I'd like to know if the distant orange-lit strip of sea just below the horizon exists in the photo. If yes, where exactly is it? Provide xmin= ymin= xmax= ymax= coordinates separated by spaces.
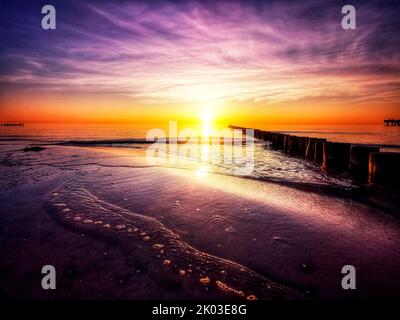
xmin=0 ymin=123 xmax=400 ymax=149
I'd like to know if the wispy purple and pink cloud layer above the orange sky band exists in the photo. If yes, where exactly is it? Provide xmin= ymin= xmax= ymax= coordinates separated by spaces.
xmin=0 ymin=1 xmax=400 ymax=103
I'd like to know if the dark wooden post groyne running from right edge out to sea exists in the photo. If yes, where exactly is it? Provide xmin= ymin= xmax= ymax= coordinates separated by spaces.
xmin=229 ymin=125 xmax=400 ymax=192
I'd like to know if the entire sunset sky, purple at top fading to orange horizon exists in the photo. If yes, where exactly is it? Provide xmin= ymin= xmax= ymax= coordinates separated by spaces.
xmin=0 ymin=0 xmax=400 ymax=125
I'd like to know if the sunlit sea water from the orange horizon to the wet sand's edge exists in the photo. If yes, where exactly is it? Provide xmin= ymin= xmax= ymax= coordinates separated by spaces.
xmin=0 ymin=124 xmax=400 ymax=187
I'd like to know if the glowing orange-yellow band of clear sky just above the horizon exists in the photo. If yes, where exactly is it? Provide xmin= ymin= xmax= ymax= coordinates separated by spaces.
xmin=0 ymin=93 xmax=400 ymax=125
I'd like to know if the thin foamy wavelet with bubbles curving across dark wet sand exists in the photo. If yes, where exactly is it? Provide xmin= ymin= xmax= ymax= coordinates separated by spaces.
xmin=47 ymin=182 xmax=302 ymax=299
